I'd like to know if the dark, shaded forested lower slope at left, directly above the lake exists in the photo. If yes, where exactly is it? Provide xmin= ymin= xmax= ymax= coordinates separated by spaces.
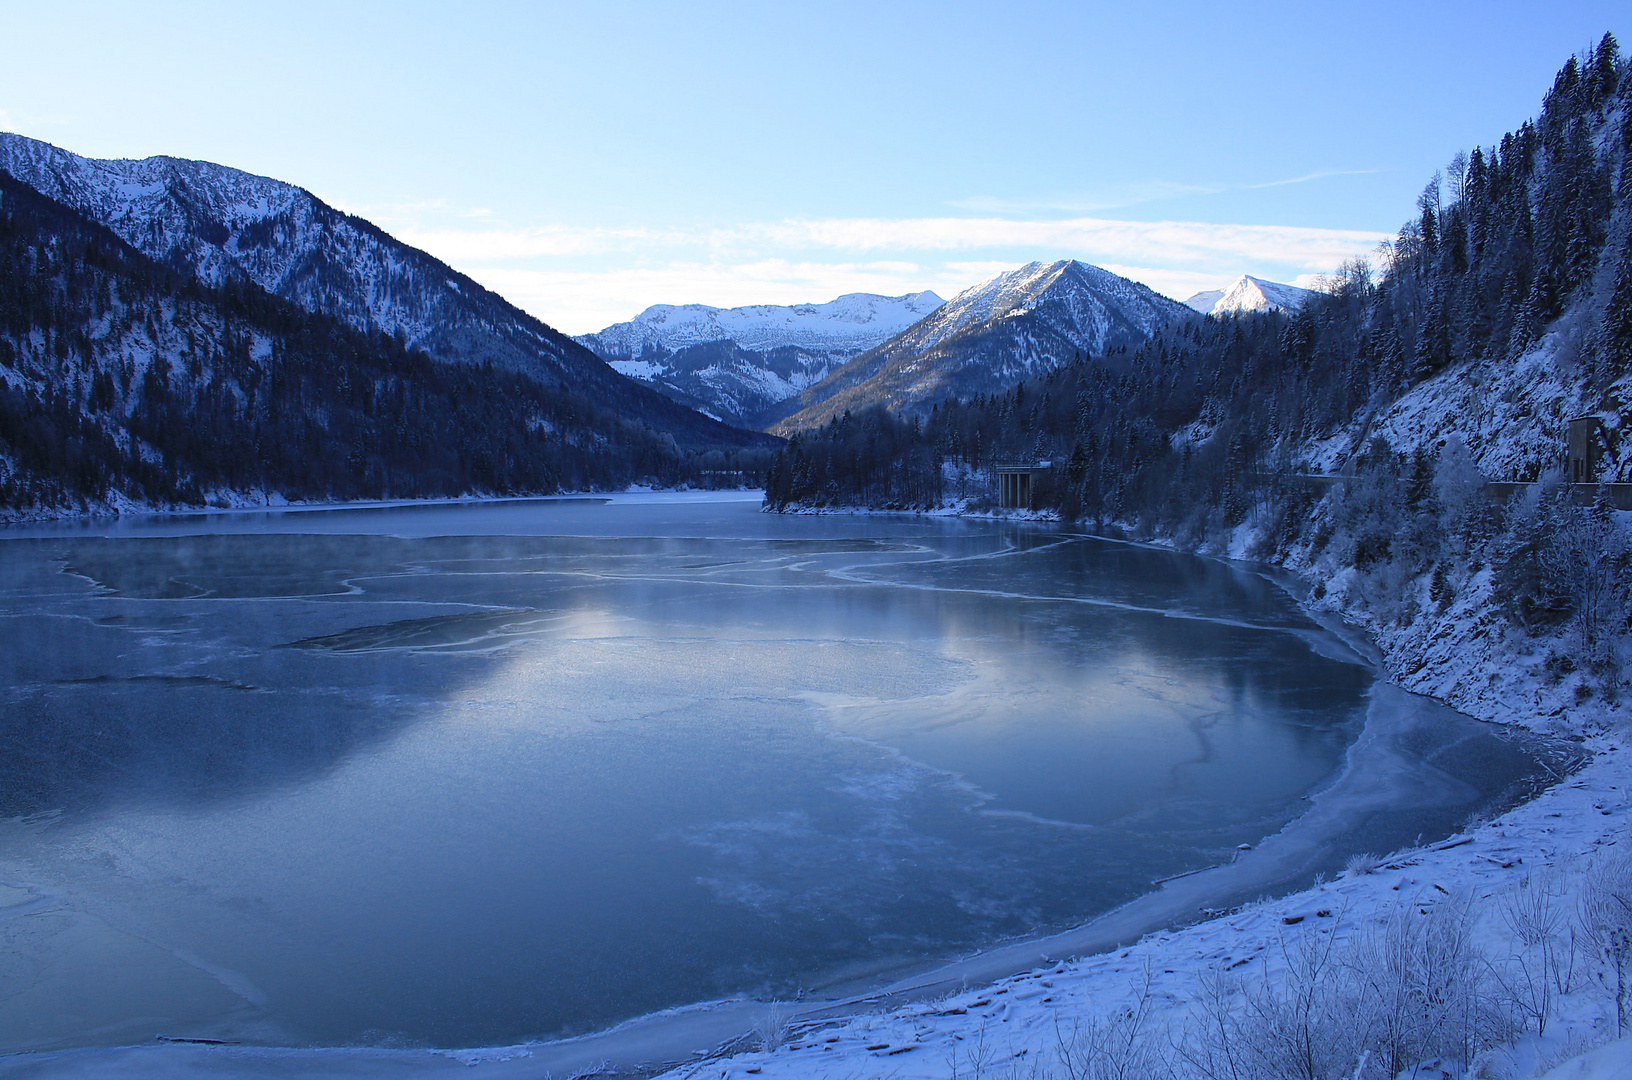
xmin=0 ymin=171 xmax=757 ymax=516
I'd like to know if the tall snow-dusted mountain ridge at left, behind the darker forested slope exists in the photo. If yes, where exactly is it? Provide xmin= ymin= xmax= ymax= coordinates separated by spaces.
xmin=0 ymin=132 xmax=753 ymax=442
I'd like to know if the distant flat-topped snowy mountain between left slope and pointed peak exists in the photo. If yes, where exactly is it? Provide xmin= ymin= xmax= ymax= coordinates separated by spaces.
xmin=576 ymin=292 xmax=942 ymax=427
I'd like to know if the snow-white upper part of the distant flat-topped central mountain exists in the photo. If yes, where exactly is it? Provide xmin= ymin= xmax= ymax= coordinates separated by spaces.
xmin=578 ymin=290 xmax=942 ymax=357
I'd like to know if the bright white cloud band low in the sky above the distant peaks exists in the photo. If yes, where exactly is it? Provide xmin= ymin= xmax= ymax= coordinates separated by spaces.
xmin=381 ymin=215 xmax=1389 ymax=333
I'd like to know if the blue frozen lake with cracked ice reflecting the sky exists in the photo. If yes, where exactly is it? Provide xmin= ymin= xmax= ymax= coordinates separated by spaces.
xmin=0 ymin=494 xmax=1532 ymax=1052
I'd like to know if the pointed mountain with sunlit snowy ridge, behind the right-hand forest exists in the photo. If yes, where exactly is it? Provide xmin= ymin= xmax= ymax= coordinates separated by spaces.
xmin=774 ymin=259 xmax=1190 ymax=432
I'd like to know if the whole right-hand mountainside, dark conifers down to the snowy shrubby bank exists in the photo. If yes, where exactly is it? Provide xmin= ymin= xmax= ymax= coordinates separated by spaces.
xmin=767 ymin=36 xmax=1632 ymax=723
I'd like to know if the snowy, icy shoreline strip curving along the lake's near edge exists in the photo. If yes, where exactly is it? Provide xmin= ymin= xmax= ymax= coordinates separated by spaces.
xmin=0 ymin=496 xmax=1632 ymax=1077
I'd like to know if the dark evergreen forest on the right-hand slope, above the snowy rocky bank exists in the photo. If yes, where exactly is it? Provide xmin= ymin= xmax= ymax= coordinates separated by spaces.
xmin=767 ymin=34 xmax=1632 ymax=532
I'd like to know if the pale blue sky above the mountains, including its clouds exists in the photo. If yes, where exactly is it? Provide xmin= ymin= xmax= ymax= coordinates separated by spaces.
xmin=0 ymin=0 xmax=1632 ymax=333
